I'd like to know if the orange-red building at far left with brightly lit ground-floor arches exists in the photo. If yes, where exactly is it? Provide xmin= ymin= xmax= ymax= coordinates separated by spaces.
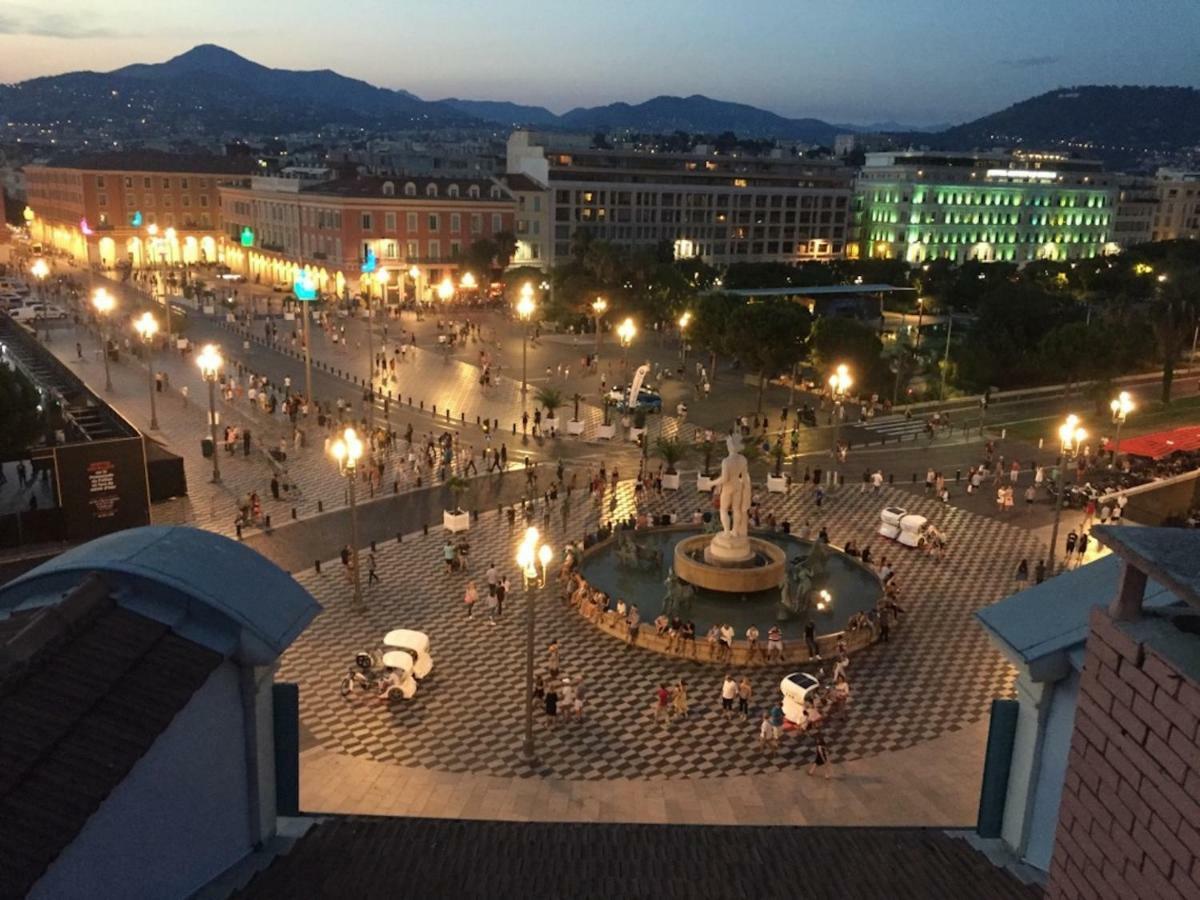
xmin=25 ymin=150 xmax=251 ymax=269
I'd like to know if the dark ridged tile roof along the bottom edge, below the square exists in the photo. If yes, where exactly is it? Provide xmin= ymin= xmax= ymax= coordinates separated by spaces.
xmin=235 ymin=817 xmax=1042 ymax=900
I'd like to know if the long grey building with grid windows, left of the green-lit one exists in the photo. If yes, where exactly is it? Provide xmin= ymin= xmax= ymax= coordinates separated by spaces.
xmin=508 ymin=131 xmax=853 ymax=265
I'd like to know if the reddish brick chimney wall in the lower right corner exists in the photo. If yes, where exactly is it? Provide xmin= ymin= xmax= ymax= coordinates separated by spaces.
xmin=1046 ymin=607 xmax=1200 ymax=899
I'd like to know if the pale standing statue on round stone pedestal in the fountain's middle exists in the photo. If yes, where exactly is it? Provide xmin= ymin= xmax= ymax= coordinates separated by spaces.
xmin=674 ymin=433 xmax=787 ymax=594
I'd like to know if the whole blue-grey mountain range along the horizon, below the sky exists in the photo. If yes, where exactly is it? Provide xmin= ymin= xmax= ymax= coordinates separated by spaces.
xmin=0 ymin=44 xmax=1200 ymax=165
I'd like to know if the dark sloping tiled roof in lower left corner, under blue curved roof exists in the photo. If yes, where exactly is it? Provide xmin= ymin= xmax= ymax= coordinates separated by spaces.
xmin=0 ymin=577 xmax=222 ymax=898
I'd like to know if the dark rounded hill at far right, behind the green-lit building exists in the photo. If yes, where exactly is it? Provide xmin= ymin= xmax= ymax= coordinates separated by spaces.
xmin=924 ymin=85 xmax=1200 ymax=162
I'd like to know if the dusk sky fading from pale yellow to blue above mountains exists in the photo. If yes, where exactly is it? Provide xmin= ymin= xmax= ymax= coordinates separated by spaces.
xmin=0 ymin=0 xmax=1200 ymax=126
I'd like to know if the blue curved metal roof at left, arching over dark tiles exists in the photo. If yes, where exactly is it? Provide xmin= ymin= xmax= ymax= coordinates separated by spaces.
xmin=0 ymin=526 xmax=320 ymax=665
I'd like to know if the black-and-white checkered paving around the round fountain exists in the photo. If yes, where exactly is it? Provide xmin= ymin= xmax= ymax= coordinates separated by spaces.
xmin=278 ymin=482 xmax=1036 ymax=779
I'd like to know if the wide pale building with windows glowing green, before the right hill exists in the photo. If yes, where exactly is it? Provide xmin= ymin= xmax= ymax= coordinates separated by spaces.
xmin=857 ymin=150 xmax=1120 ymax=264
